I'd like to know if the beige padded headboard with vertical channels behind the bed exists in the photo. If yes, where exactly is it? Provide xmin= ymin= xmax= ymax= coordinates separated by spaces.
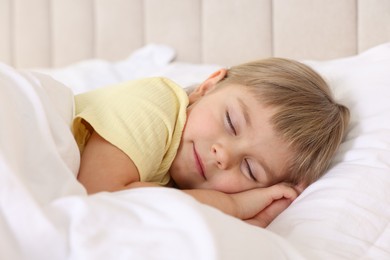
xmin=0 ymin=0 xmax=390 ymax=68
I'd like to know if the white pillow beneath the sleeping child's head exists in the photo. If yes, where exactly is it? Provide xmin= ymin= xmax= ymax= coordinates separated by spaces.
xmin=268 ymin=43 xmax=390 ymax=259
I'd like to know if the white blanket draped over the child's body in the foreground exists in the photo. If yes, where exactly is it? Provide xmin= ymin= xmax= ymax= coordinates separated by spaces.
xmin=0 ymin=64 xmax=302 ymax=260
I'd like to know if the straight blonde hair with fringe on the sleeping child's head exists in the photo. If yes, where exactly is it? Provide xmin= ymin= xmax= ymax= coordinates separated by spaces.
xmin=221 ymin=58 xmax=349 ymax=185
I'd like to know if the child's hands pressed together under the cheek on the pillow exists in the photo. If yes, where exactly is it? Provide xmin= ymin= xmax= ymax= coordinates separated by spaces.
xmin=232 ymin=183 xmax=298 ymax=227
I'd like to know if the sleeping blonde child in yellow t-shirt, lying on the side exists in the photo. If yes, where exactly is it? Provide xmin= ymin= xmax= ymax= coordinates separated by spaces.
xmin=73 ymin=58 xmax=349 ymax=227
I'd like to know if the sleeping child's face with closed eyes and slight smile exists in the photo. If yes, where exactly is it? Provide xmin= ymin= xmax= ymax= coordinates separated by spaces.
xmin=169 ymin=69 xmax=292 ymax=193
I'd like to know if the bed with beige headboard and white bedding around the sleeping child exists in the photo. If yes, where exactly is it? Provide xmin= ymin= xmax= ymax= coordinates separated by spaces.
xmin=0 ymin=0 xmax=390 ymax=260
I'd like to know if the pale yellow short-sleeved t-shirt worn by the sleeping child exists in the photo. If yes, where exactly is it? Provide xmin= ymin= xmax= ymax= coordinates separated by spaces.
xmin=73 ymin=78 xmax=188 ymax=185
